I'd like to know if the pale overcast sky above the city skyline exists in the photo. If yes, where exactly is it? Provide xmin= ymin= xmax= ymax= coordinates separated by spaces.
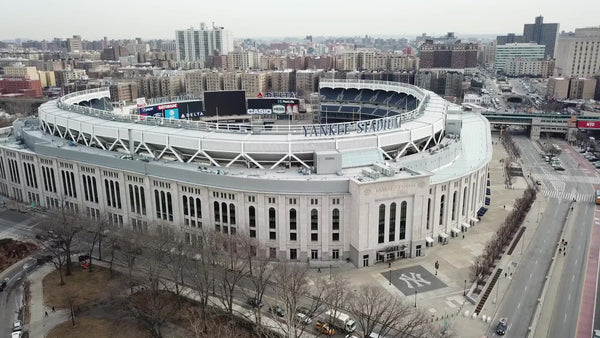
xmin=0 ymin=0 xmax=600 ymax=40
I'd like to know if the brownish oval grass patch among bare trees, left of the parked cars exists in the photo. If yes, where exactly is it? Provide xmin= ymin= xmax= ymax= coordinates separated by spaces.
xmin=42 ymin=264 xmax=118 ymax=309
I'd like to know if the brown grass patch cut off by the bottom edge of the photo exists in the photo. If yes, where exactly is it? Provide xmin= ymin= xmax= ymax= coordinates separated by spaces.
xmin=46 ymin=317 xmax=149 ymax=338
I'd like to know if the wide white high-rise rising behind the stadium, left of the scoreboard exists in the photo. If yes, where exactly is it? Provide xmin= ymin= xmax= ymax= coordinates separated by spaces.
xmin=175 ymin=23 xmax=233 ymax=63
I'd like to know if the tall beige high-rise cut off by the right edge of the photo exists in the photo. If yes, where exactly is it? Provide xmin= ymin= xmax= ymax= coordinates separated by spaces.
xmin=555 ymin=27 xmax=600 ymax=77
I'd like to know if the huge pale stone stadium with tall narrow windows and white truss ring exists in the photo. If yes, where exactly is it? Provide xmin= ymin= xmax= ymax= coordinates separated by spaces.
xmin=0 ymin=80 xmax=492 ymax=267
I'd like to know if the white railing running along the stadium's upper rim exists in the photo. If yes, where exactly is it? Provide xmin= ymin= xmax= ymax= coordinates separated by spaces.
xmin=56 ymin=81 xmax=429 ymax=134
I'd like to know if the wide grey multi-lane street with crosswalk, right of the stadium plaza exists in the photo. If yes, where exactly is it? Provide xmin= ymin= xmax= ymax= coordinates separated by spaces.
xmin=488 ymin=137 xmax=595 ymax=337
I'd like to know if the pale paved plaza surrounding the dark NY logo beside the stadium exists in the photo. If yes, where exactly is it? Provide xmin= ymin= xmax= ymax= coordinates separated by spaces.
xmin=304 ymin=135 xmax=546 ymax=338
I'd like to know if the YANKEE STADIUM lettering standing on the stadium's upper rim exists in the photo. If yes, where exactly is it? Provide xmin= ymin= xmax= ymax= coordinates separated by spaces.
xmin=302 ymin=116 xmax=401 ymax=137
